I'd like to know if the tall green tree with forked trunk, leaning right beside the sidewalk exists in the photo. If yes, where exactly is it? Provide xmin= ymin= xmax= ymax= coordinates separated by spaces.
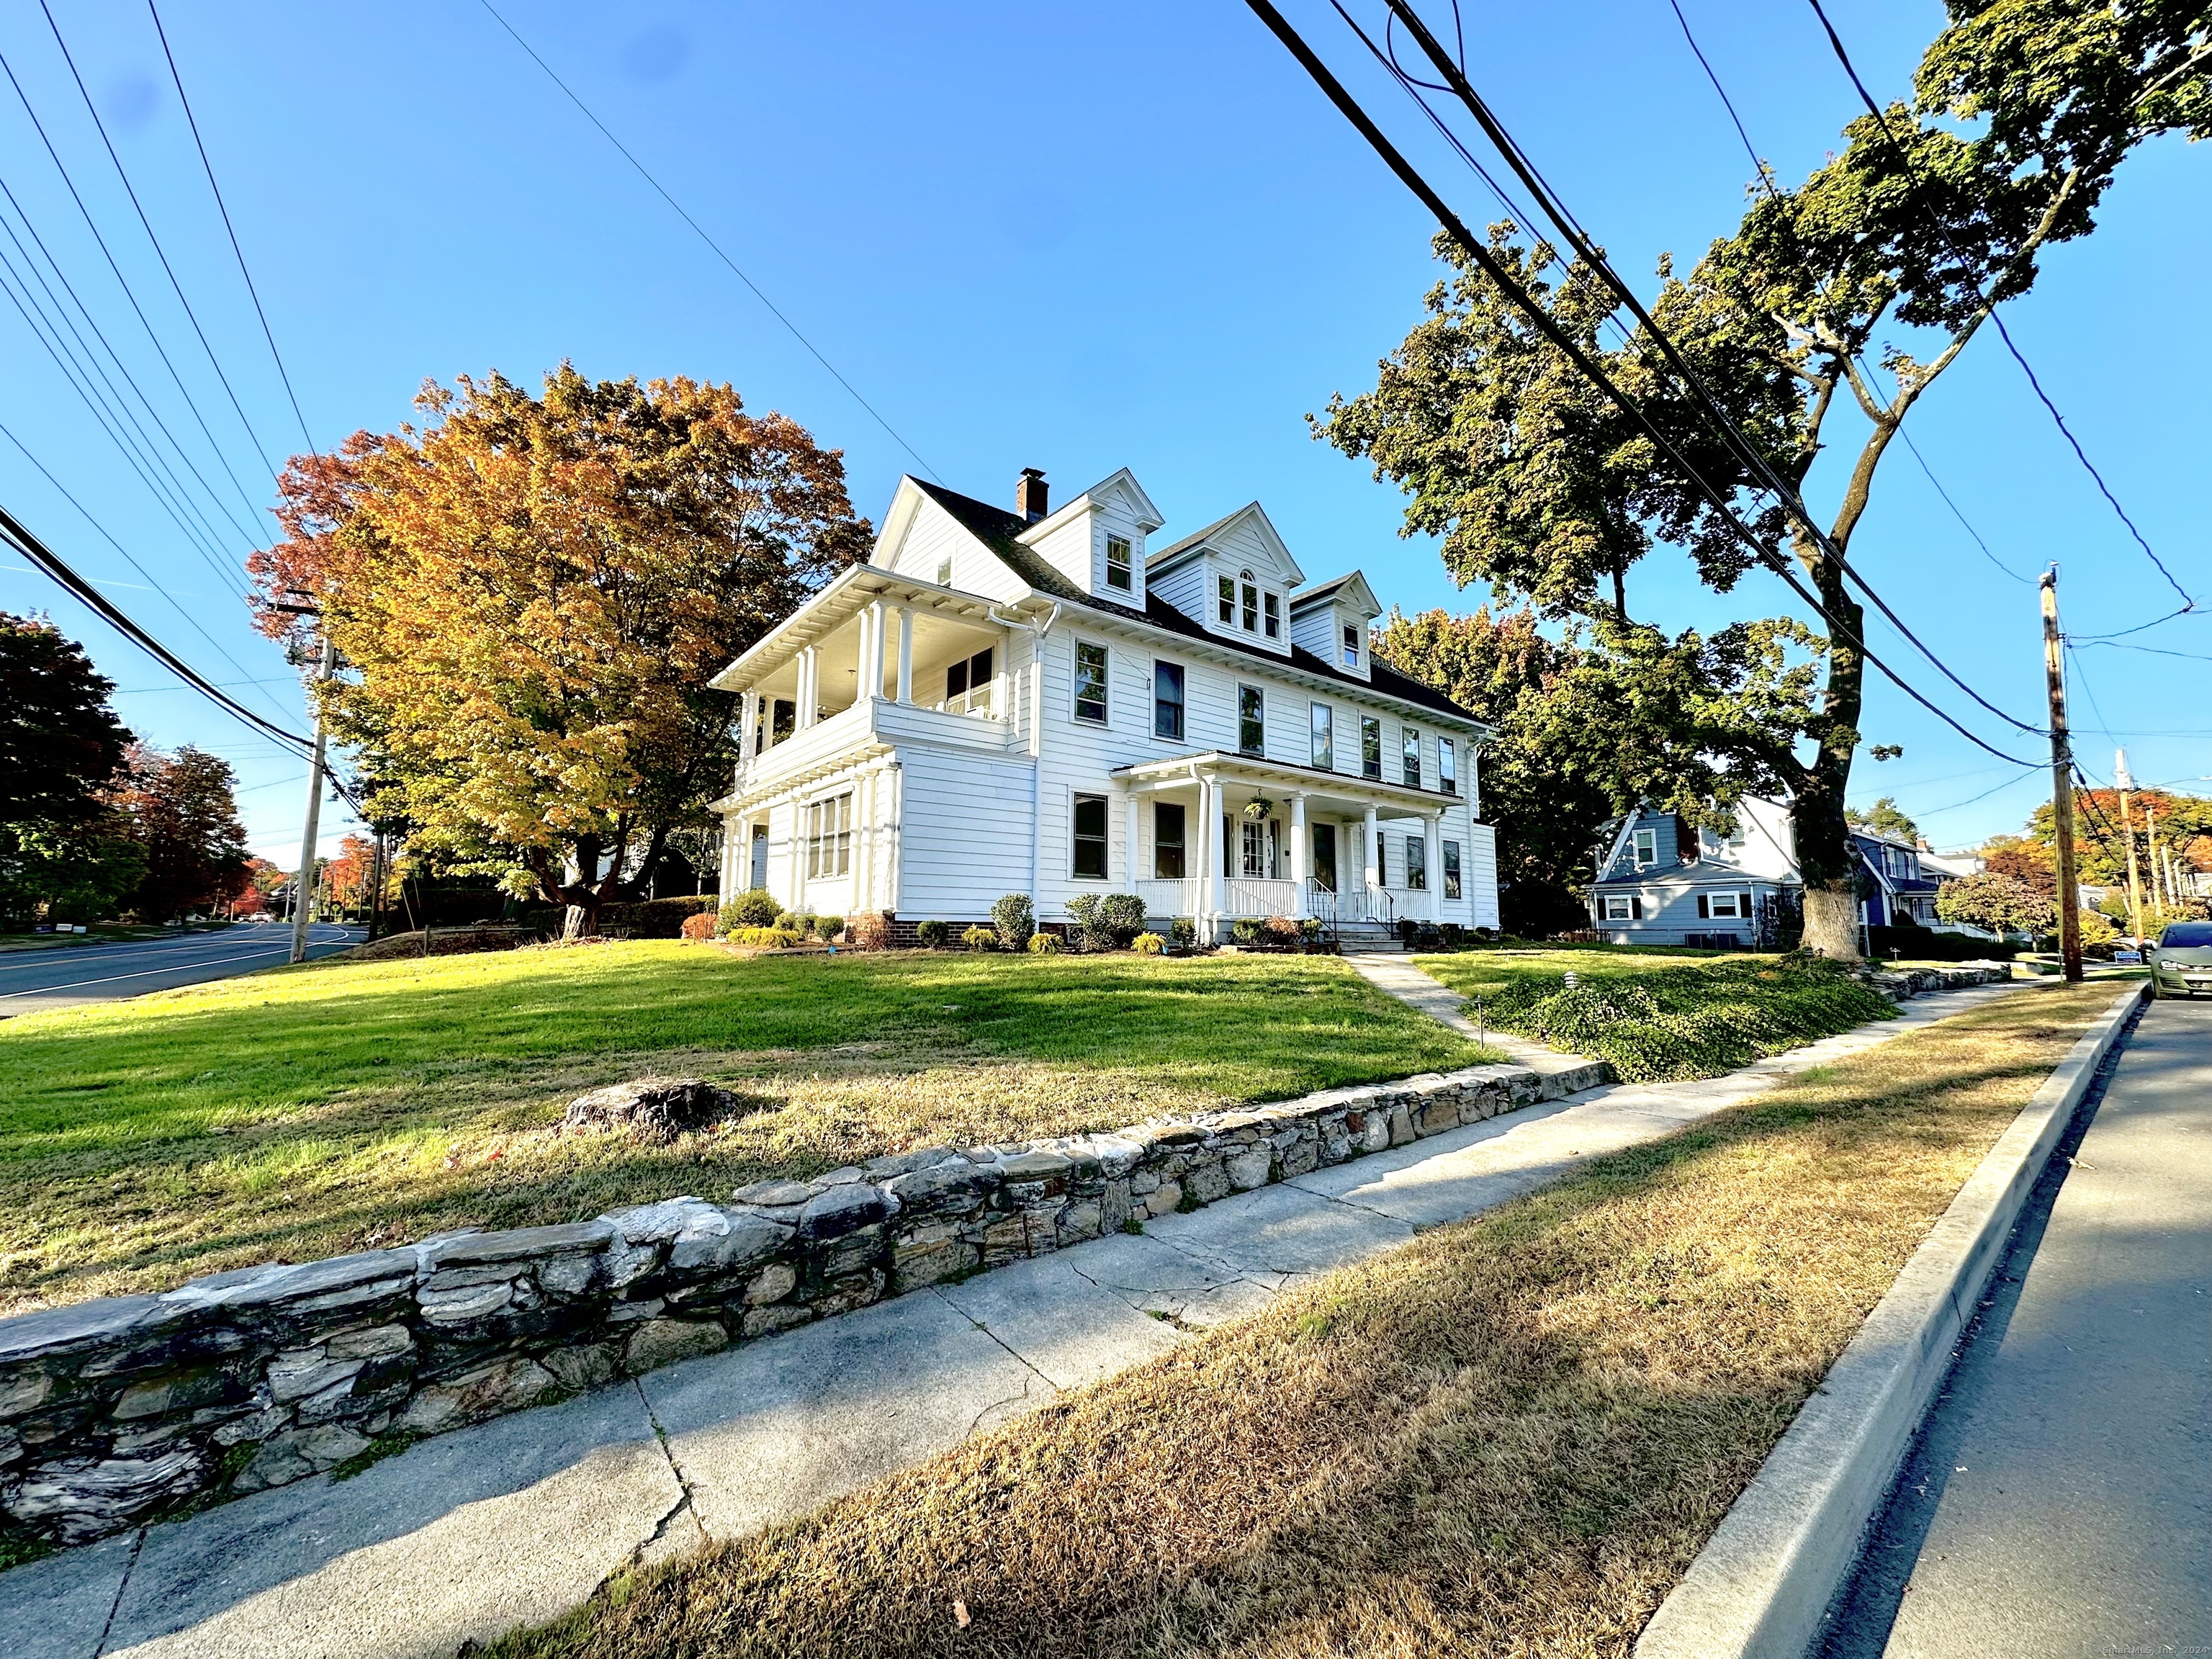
xmin=1318 ymin=0 xmax=2212 ymax=956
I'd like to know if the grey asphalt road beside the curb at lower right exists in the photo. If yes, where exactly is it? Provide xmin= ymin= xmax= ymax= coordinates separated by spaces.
xmin=1825 ymin=1002 xmax=2212 ymax=1659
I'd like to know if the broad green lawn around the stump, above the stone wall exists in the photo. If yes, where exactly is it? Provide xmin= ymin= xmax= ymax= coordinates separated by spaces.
xmin=0 ymin=940 xmax=1484 ymax=1314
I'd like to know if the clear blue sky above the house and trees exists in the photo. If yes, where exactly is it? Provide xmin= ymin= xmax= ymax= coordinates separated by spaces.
xmin=0 ymin=0 xmax=2212 ymax=867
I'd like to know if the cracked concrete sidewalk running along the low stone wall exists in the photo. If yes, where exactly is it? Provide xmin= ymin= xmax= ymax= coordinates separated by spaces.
xmin=0 ymin=986 xmax=2006 ymax=1659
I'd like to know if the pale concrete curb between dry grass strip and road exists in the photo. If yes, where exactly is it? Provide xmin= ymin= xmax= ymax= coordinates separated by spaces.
xmin=1635 ymin=984 xmax=2148 ymax=1659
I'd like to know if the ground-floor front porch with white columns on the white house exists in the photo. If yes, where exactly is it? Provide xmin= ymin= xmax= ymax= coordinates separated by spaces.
xmin=1115 ymin=752 xmax=1449 ymax=938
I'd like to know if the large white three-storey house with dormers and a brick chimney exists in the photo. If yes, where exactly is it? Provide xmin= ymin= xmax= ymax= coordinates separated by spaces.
xmin=714 ymin=469 xmax=1498 ymax=938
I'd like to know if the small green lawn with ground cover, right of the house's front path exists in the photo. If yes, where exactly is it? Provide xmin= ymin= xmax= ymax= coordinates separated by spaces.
xmin=1413 ymin=949 xmax=1896 ymax=1082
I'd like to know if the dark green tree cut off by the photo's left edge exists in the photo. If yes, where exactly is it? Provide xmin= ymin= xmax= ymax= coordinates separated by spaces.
xmin=0 ymin=611 xmax=144 ymax=922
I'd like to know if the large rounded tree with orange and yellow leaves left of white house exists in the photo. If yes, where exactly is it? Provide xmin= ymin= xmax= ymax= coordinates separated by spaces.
xmin=252 ymin=363 xmax=869 ymax=933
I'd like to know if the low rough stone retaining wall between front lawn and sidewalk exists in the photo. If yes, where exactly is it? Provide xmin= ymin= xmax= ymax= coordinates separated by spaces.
xmin=0 ymin=1064 xmax=1610 ymax=1544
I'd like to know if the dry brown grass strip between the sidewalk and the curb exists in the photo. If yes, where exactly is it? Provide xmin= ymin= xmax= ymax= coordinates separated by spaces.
xmin=502 ymin=984 xmax=2113 ymax=1659
